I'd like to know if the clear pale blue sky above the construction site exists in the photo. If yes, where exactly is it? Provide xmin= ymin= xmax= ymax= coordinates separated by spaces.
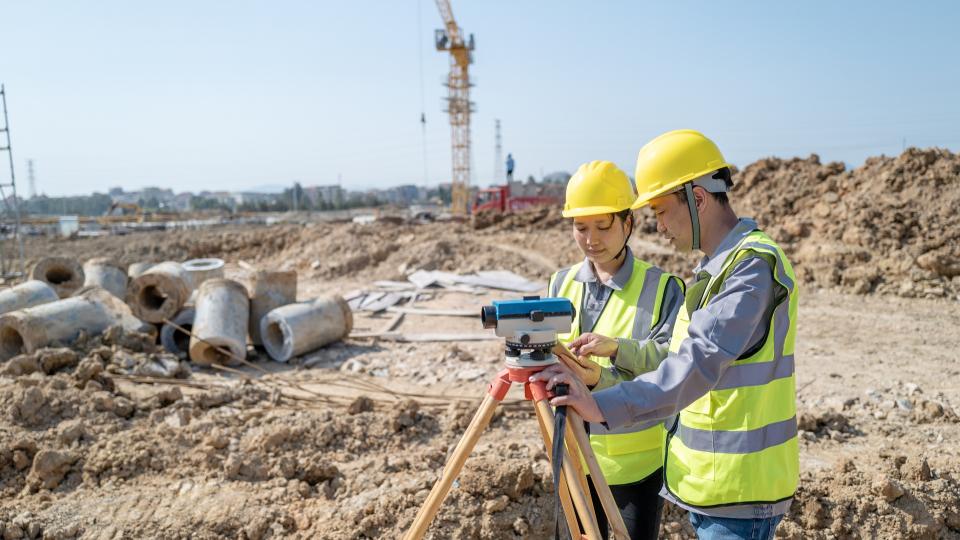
xmin=0 ymin=0 xmax=960 ymax=196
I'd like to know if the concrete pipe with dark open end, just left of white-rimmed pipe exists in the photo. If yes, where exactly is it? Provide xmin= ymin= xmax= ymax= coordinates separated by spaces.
xmin=126 ymin=261 xmax=193 ymax=323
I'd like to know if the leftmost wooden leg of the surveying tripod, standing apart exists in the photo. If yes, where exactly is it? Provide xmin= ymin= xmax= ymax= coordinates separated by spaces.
xmin=404 ymin=394 xmax=500 ymax=540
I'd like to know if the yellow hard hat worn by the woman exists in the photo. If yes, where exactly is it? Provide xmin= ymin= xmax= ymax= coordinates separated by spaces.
xmin=563 ymin=161 xmax=637 ymax=217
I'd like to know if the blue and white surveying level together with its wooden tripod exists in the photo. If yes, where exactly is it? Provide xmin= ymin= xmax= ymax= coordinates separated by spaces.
xmin=404 ymin=296 xmax=629 ymax=540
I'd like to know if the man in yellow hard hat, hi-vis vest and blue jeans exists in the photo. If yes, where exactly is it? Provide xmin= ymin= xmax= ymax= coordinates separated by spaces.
xmin=531 ymin=130 xmax=799 ymax=539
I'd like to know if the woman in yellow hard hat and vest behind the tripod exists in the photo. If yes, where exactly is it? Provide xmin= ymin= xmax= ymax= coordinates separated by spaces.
xmin=549 ymin=161 xmax=683 ymax=540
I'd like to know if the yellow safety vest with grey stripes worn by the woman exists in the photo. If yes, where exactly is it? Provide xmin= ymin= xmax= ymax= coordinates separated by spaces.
xmin=548 ymin=258 xmax=682 ymax=485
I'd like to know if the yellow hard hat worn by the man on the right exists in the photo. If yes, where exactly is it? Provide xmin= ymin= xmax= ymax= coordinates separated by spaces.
xmin=632 ymin=129 xmax=730 ymax=209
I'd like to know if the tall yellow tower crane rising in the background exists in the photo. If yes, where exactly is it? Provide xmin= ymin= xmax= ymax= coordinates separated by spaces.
xmin=434 ymin=0 xmax=474 ymax=216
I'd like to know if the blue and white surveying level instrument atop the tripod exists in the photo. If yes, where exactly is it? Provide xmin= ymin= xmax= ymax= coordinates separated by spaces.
xmin=480 ymin=296 xmax=577 ymax=368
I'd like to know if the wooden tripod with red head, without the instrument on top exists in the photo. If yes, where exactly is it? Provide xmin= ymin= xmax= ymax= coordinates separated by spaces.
xmin=404 ymin=365 xmax=629 ymax=540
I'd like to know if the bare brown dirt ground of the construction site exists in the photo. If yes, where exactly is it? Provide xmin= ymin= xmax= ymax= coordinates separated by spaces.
xmin=0 ymin=146 xmax=960 ymax=539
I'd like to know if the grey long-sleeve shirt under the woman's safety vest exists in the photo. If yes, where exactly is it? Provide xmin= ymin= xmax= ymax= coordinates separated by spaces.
xmin=550 ymin=248 xmax=683 ymax=382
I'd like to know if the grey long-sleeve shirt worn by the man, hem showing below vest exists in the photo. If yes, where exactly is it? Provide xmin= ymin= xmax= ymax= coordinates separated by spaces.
xmin=594 ymin=219 xmax=792 ymax=518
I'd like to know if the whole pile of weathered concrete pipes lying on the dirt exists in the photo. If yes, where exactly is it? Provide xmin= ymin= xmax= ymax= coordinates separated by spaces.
xmin=0 ymin=257 xmax=353 ymax=365
